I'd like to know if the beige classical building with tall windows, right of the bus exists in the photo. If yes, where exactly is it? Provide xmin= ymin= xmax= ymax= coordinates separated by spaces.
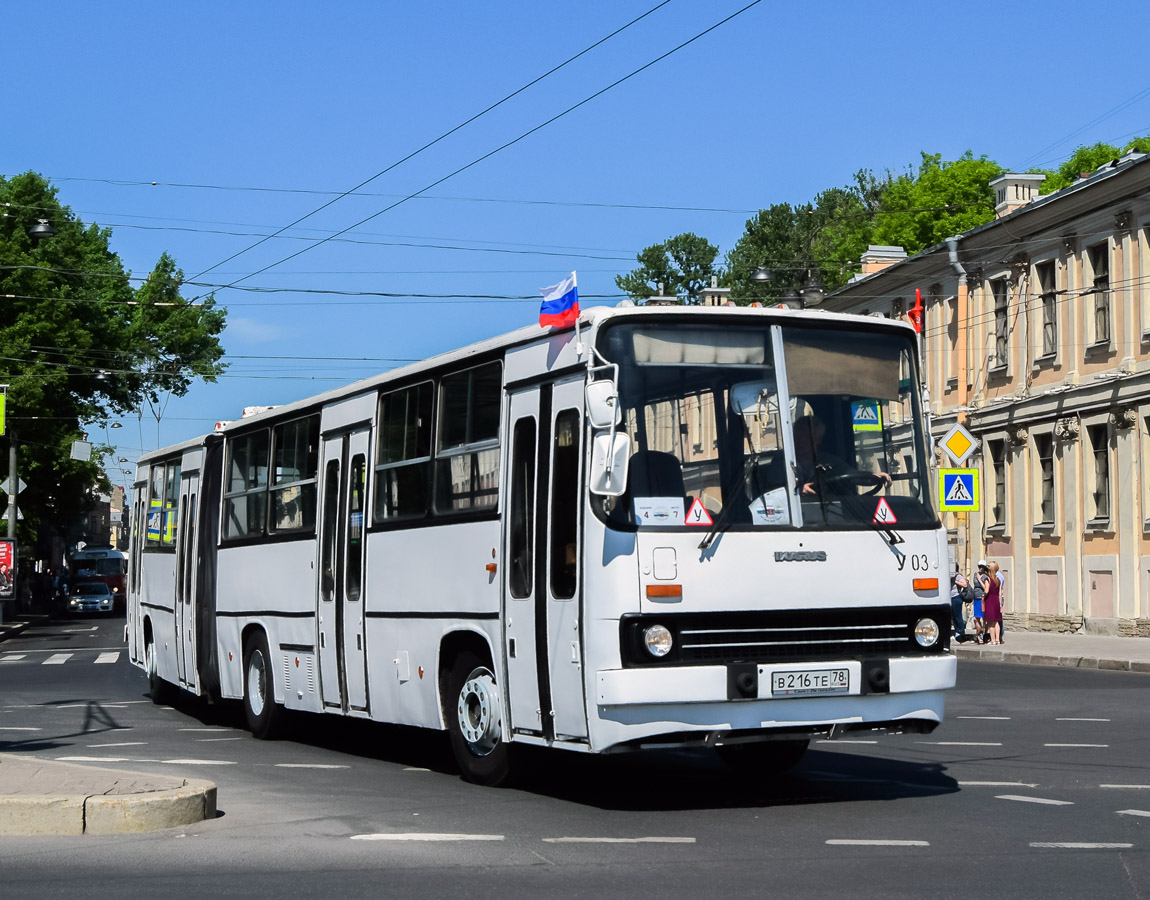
xmin=822 ymin=153 xmax=1150 ymax=636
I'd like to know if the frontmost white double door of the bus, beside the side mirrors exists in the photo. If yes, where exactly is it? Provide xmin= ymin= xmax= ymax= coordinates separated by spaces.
xmin=503 ymin=377 xmax=587 ymax=740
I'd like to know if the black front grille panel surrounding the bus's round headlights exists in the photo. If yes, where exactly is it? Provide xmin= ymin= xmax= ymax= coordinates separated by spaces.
xmin=622 ymin=606 xmax=951 ymax=666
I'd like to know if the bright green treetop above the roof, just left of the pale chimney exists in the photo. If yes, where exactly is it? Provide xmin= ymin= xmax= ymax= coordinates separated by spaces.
xmin=873 ymin=151 xmax=1004 ymax=255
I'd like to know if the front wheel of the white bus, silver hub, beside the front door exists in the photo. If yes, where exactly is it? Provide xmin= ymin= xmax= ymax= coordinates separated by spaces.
xmin=446 ymin=653 xmax=511 ymax=786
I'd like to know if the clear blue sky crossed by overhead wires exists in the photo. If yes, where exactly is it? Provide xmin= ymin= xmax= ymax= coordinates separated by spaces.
xmin=0 ymin=0 xmax=1150 ymax=478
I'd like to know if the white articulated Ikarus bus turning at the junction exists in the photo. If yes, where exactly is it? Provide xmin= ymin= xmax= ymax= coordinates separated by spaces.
xmin=129 ymin=307 xmax=956 ymax=784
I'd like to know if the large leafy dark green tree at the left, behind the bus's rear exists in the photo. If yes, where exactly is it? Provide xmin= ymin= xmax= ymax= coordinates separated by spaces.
xmin=0 ymin=172 xmax=225 ymax=541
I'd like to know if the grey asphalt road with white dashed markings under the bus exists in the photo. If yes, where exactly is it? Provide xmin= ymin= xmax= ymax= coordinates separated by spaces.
xmin=0 ymin=620 xmax=1150 ymax=900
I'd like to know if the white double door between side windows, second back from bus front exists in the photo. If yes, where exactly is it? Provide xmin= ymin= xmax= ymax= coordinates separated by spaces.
xmin=317 ymin=429 xmax=368 ymax=711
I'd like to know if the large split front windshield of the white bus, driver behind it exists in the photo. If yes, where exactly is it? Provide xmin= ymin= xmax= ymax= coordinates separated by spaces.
xmin=599 ymin=322 xmax=938 ymax=531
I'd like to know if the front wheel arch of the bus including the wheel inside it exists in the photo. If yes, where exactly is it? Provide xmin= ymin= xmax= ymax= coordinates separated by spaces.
xmin=439 ymin=632 xmax=511 ymax=786
